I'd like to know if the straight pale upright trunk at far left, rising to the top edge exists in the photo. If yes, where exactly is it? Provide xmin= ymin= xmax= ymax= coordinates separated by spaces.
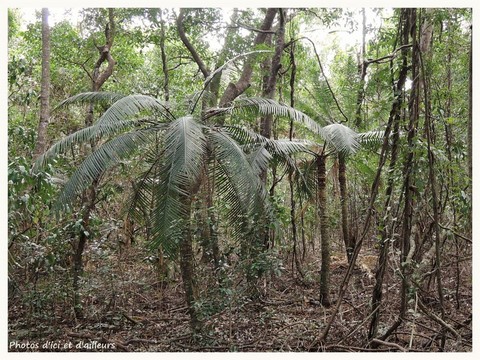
xmin=33 ymin=8 xmax=50 ymax=159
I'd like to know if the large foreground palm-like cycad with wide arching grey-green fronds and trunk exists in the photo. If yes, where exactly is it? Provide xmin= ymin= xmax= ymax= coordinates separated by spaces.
xmin=36 ymin=92 xmax=323 ymax=330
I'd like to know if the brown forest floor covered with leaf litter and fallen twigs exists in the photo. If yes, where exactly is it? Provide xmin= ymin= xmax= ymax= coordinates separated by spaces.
xmin=8 ymin=245 xmax=472 ymax=352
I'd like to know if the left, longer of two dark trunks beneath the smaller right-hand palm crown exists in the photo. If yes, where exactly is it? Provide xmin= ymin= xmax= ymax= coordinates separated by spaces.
xmin=316 ymin=154 xmax=330 ymax=306
